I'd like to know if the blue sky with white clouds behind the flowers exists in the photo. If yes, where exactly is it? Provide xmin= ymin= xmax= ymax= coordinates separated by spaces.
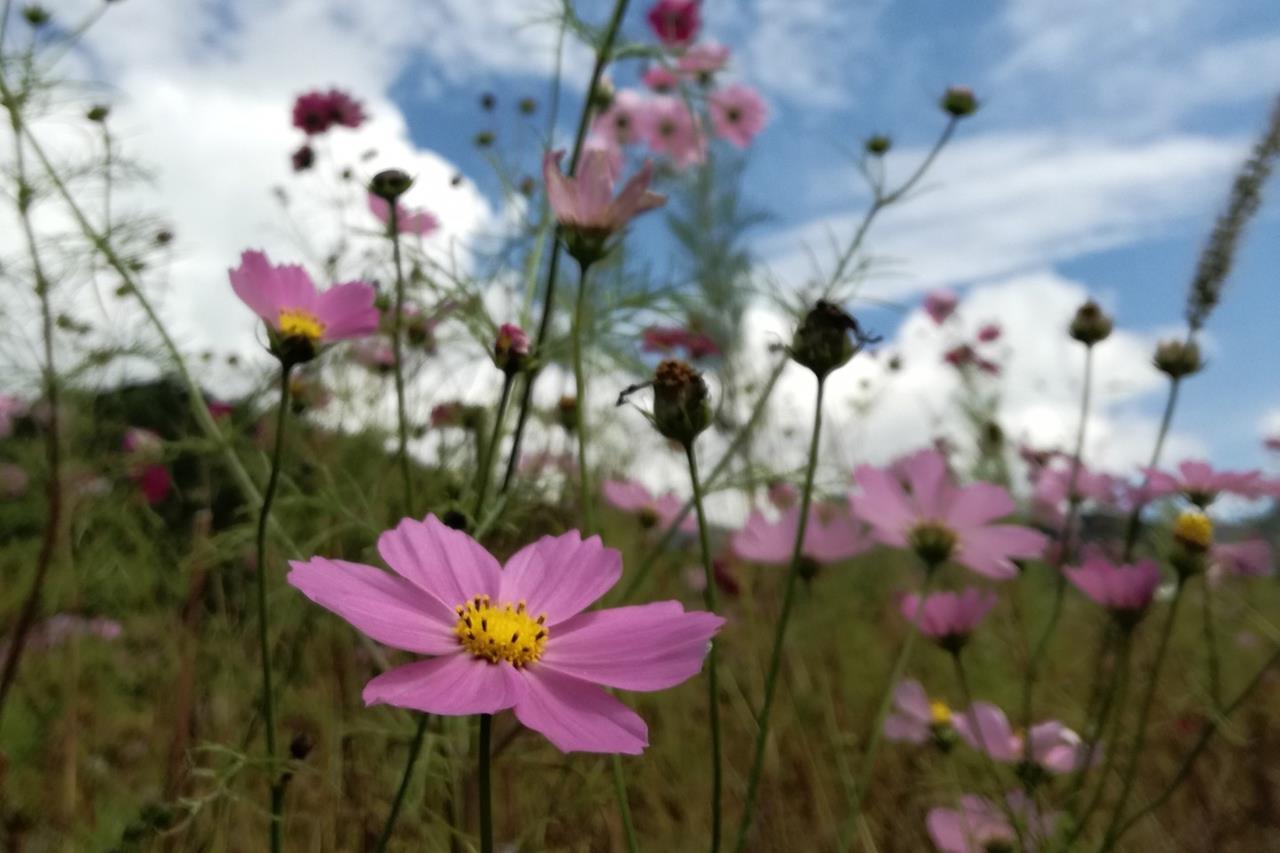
xmin=10 ymin=0 xmax=1280 ymax=502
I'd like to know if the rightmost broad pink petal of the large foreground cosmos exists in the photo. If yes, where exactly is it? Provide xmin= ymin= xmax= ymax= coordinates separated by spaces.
xmin=541 ymin=601 xmax=724 ymax=690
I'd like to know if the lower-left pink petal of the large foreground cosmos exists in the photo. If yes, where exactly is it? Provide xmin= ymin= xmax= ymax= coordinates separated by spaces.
xmin=364 ymin=653 xmax=530 ymax=716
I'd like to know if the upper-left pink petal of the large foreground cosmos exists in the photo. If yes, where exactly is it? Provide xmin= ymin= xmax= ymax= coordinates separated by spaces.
xmin=378 ymin=515 xmax=502 ymax=611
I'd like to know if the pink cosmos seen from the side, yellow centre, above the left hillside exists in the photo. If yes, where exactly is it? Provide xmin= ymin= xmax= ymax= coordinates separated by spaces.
xmin=229 ymin=251 xmax=378 ymax=343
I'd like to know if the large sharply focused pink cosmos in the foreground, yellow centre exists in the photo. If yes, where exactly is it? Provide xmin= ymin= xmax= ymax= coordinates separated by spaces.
xmin=288 ymin=515 xmax=724 ymax=754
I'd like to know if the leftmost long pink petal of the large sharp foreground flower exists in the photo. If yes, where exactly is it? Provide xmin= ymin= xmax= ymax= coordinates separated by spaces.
xmin=288 ymin=557 xmax=458 ymax=654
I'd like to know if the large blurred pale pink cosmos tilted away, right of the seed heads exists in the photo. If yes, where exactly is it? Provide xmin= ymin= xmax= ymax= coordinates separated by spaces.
xmin=854 ymin=451 xmax=1046 ymax=580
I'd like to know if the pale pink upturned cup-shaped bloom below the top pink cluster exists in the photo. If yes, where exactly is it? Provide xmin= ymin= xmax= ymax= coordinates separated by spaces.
xmin=543 ymin=150 xmax=667 ymax=236
